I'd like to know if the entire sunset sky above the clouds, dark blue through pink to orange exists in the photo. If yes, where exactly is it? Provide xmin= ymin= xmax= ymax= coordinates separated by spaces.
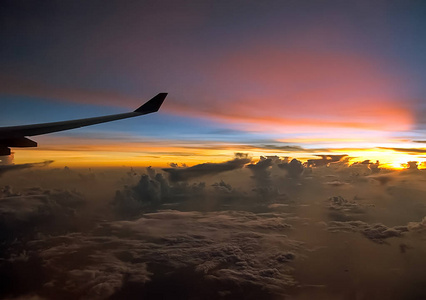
xmin=0 ymin=1 xmax=426 ymax=167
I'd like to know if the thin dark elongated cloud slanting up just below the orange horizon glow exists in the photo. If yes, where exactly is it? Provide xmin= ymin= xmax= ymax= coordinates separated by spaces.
xmin=163 ymin=153 xmax=251 ymax=182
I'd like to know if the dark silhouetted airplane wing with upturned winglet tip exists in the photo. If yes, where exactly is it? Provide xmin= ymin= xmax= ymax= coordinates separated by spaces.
xmin=0 ymin=93 xmax=167 ymax=155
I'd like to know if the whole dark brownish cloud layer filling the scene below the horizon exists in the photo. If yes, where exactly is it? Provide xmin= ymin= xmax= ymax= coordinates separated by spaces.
xmin=0 ymin=155 xmax=426 ymax=299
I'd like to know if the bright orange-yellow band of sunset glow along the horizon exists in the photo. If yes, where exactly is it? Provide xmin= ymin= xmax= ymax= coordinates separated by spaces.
xmin=9 ymin=139 xmax=426 ymax=170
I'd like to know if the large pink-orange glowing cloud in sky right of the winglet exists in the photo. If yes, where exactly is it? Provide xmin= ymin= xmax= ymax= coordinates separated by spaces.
xmin=169 ymin=48 xmax=413 ymax=131
